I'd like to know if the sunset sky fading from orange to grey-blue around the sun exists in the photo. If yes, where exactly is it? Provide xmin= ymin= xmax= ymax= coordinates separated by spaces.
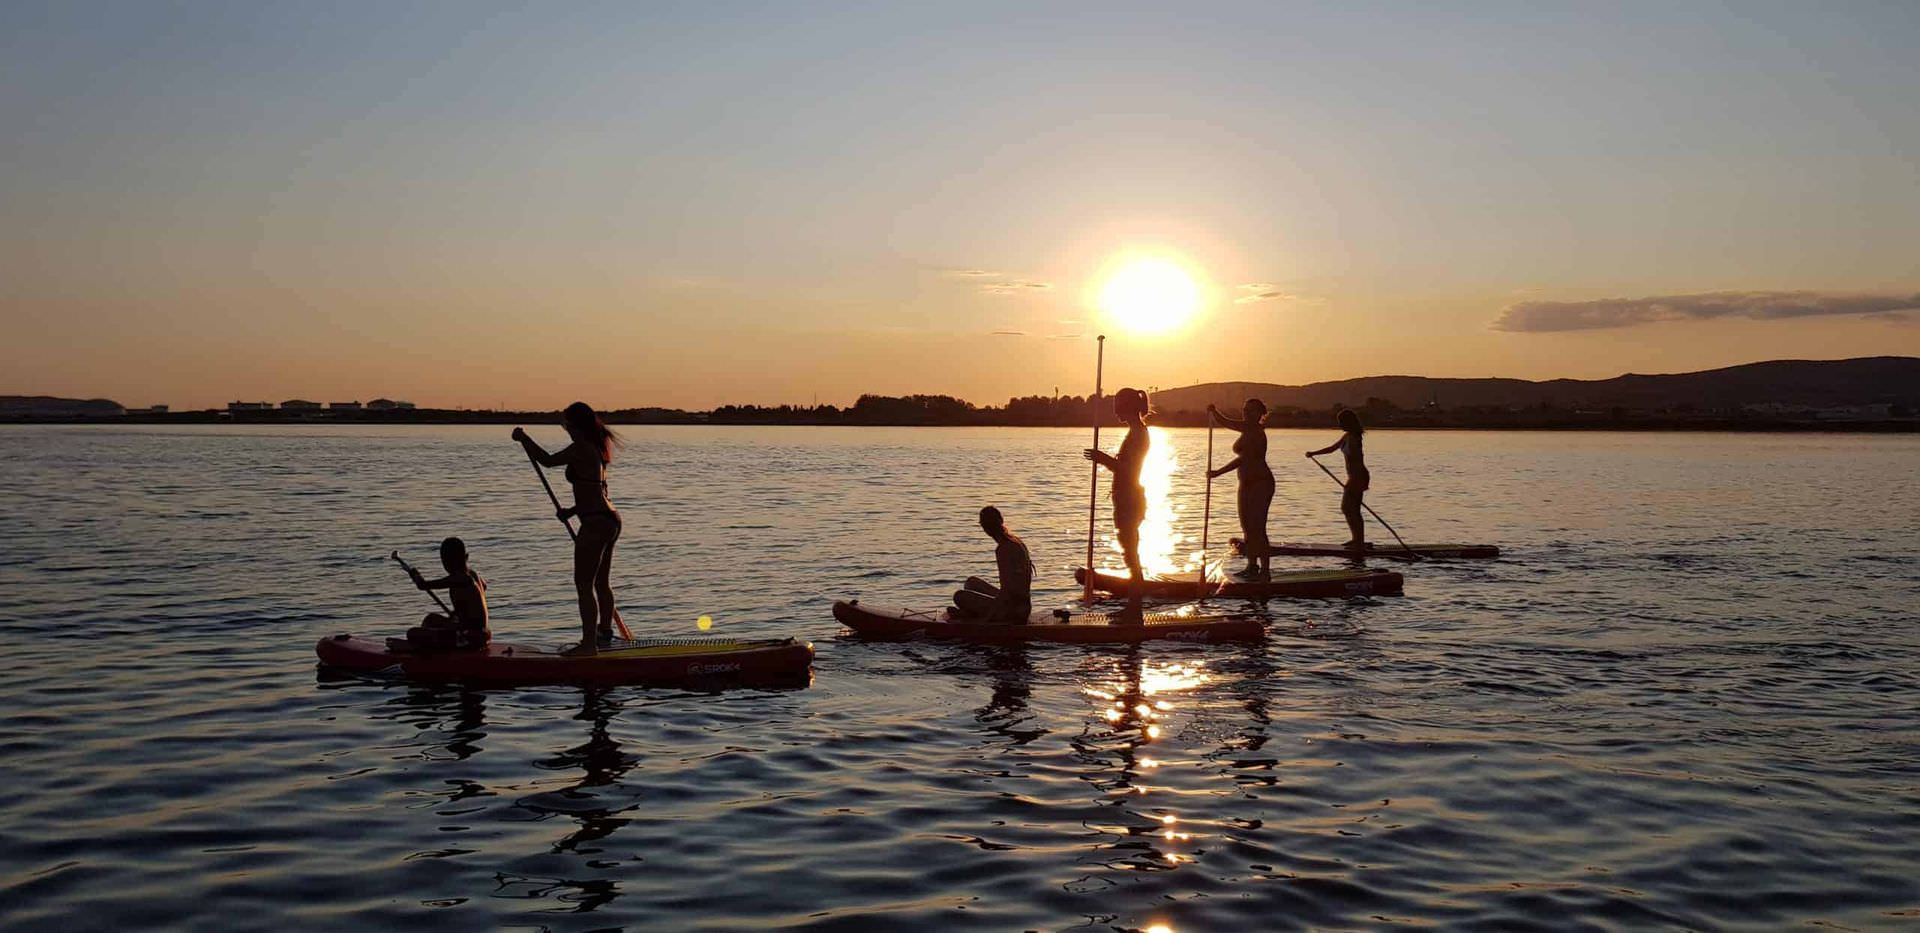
xmin=0 ymin=0 xmax=1920 ymax=409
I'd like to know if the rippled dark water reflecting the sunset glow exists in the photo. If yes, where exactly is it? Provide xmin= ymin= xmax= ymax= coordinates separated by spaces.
xmin=0 ymin=426 xmax=1920 ymax=931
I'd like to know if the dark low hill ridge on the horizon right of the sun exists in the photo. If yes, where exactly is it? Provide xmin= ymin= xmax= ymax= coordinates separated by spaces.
xmin=1154 ymin=357 xmax=1920 ymax=411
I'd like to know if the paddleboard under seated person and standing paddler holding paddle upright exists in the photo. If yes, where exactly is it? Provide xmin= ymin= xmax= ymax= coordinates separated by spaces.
xmin=833 ymin=599 xmax=1267 ymax=643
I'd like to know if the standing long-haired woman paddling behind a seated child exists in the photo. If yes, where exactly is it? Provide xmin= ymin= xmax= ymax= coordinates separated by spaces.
xmin=513 ymin=401 xmax=620 ymax=655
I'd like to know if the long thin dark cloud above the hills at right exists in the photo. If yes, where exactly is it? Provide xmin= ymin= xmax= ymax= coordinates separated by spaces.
xmin=1494 ymin=292 xmax=1920 ymax=332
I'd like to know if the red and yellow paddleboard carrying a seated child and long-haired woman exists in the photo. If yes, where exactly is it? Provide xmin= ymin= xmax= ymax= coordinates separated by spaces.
xmin=313 ymin=635 xmax=814 ymax=687
